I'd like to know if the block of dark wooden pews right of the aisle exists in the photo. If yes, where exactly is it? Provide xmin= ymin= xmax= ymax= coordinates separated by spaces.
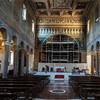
xmin=69 ymin=76 xmax=100 ymax=100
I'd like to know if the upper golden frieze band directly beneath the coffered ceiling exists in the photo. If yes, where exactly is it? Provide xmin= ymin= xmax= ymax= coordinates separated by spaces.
xmin=37 ymin=17 xmax=86 ymax=26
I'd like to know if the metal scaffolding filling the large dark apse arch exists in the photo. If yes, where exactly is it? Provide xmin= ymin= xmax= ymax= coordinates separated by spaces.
xmin=40 ymin=35 xmax=80 ymax=63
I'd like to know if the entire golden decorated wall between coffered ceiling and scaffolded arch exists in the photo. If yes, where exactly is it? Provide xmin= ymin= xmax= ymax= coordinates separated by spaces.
xmin=37 ymin=17 xmax=86 ymax=49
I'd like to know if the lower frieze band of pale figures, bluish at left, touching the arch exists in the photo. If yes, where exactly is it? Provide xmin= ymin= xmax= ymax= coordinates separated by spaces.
xmin=38 ymin=28 xmax=83 ymax=41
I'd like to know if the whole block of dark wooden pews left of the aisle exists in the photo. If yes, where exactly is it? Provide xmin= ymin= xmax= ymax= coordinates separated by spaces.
xmin=0 ymin=75 xmax=50 ymax=100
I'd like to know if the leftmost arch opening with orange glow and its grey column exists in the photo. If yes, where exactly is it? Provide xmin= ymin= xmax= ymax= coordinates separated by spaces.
xmin=0 ymin=26 xmax=9 ymax=78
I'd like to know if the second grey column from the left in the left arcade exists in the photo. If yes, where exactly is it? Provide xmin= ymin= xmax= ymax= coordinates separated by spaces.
xmin=14 ymin=45 xmax=19 ymax=77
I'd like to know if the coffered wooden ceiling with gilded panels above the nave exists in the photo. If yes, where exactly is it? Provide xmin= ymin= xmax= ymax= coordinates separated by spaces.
xmin=29 ymin=0 xmax=94 ymax=17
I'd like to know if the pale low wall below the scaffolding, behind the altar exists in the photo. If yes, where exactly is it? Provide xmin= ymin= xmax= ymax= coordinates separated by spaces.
xmin=38 ymin=63 xmax=90 ymax=73
